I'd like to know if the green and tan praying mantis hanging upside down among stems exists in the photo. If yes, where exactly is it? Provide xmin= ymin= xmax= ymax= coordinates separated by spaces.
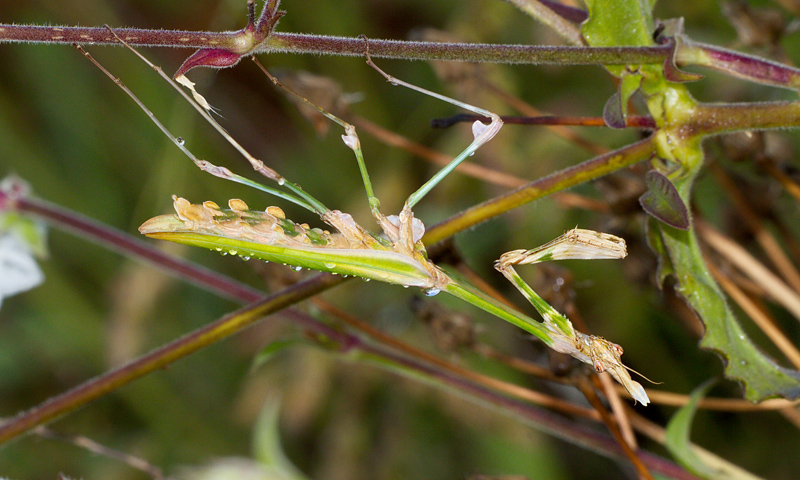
xmin=90 ymin=28 xmax=649 ymax=405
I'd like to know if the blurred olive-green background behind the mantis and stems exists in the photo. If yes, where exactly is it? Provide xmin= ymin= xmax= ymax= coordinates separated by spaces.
xmin=0 ymin=0 xmax=800 ymax=480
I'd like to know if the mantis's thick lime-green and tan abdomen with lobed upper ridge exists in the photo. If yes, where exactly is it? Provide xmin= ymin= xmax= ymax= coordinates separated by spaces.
xmin=139 ymin=196 xmax=450 ymax=292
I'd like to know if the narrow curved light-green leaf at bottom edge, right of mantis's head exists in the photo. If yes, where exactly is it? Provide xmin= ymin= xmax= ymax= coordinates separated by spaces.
xmin=665 ymin=379 xmax=730 ymax=479
